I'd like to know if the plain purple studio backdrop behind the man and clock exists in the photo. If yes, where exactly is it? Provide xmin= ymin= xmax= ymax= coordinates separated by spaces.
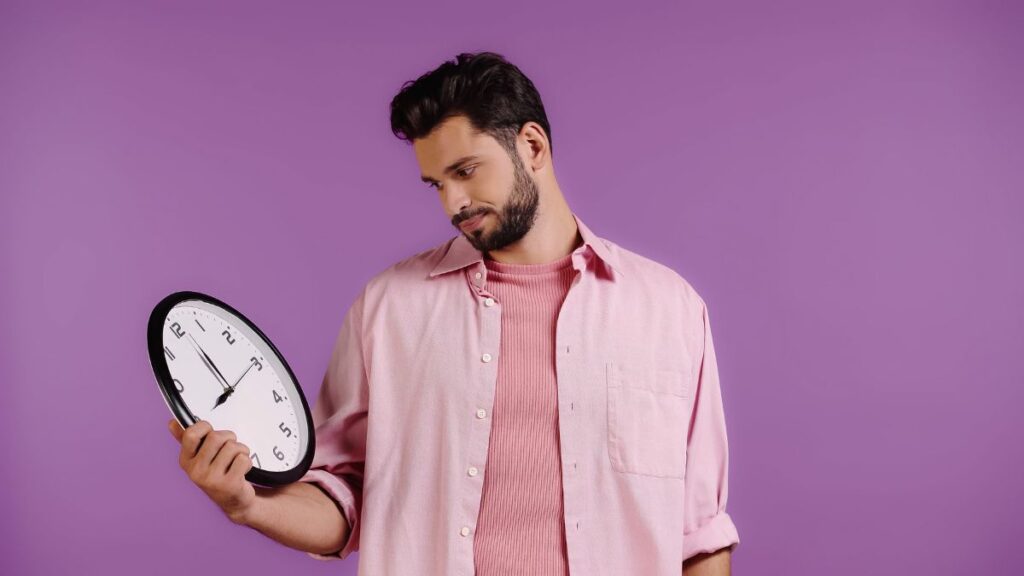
xmin=0 ymin=1 xmax=1024 ymax=576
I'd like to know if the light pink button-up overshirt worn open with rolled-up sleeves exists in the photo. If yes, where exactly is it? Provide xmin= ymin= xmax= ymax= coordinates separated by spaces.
xmin=300 ymin=214 xmax=739 ymax=576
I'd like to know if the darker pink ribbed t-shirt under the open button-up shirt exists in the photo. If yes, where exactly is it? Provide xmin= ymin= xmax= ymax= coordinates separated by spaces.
xmin=473 ymin=254 xmax=575 ymax=576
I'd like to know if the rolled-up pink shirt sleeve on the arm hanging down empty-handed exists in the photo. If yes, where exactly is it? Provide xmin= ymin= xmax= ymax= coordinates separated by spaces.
xmin=682 ymin=301 xmax=739 ymax=561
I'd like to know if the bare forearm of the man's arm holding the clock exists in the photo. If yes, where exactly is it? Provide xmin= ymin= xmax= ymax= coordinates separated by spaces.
xmin=231 ymin=482 xmax=349 ymax=554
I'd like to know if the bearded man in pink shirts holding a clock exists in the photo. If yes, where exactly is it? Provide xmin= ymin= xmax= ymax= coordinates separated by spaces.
xmin=171 ymin=52 xmax=739 ymax=576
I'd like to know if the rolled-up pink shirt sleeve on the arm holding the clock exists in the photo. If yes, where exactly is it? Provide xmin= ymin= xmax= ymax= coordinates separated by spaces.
xmin=299 ymin=290 xmax=369 ymax=560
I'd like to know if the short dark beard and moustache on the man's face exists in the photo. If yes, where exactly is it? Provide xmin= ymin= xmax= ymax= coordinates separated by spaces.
xmin=456 ymin=154 xmax=541 ymax=254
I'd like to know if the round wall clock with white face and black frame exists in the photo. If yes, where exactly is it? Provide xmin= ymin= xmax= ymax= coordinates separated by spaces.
xmin=150 ymin=292 xmax=313 ymax=485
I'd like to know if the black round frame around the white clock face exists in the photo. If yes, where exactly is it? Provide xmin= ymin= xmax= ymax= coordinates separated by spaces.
xmin=146 ymin=290 xmax=316 ymax=486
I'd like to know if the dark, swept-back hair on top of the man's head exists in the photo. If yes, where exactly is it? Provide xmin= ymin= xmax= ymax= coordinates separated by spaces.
xmin=391 ymin=52 xmax=554 ymax=155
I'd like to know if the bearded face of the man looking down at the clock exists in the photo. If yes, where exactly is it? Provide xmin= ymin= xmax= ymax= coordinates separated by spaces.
xmin=413 ymin=116 xmax=540 ymax=253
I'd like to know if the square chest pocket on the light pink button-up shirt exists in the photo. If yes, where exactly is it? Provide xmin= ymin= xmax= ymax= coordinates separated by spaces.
xmin=605 ymin=362 xmax=690 ymax=479
